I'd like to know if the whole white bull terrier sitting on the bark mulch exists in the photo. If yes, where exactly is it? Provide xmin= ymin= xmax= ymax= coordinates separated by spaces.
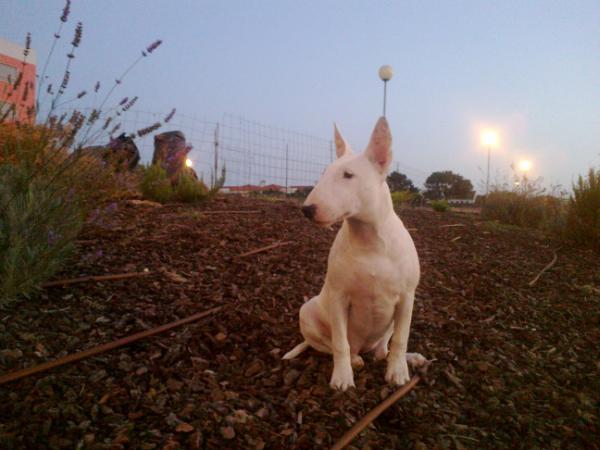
xmin=283 ymin=117 xmax=426 ymax=391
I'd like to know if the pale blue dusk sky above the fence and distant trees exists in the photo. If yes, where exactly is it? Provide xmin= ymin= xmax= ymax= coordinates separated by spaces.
xmin=0 ymin=0 xmax=600 ymax=191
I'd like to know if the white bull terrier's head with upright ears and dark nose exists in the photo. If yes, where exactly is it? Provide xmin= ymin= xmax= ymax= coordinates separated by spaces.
xmin=302 ymin=117 xmax=392 ymax=226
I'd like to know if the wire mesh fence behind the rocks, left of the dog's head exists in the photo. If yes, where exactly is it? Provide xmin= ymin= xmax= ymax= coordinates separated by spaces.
xmin=78 ymin=110 xmax=333 ymax=189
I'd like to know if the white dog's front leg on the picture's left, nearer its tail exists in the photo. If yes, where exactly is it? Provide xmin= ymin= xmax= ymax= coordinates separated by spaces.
xmin=328 ymin=298 xmax=354 ymax=391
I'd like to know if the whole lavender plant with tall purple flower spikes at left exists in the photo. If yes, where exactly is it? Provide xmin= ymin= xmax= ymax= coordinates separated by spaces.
xmin=0 ymin=0 xmax=174 ymax=306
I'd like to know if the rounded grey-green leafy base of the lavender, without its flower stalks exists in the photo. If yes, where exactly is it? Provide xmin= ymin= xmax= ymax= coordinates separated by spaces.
xmin=0 ymin=164 xmax=83 ymax=305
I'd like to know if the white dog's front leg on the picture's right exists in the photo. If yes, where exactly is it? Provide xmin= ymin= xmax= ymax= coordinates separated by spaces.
xmin=385 ymin=292 xmax=415 ymax=386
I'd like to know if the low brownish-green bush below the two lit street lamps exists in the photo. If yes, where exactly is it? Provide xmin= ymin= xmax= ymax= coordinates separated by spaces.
xmin=481 ymin=191 xmax=565 ymax=231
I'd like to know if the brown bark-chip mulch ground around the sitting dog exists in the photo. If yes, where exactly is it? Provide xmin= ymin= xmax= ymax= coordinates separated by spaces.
xmin=0 ymin=197 xmax=600 ymax=450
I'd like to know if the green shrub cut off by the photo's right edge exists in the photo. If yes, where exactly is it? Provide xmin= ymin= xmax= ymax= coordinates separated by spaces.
xmin=566 ymin=169 xmax=600 ymax=250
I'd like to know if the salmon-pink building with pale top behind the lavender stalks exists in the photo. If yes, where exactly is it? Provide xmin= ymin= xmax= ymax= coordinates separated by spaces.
xmin=0 ymin=39 xmax=36 ymax=122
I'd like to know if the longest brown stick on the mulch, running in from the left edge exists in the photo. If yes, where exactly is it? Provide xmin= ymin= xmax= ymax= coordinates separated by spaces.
xmin=0 ymin=306 xmax=222 ymax=385
